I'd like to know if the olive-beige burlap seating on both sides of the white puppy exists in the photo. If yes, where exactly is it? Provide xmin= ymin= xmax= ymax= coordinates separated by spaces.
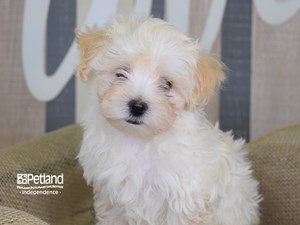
xmin=0 ymin=125 xmax=300 ymax=225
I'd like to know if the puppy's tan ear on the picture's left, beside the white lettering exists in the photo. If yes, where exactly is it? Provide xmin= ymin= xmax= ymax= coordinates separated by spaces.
xmin=75 ymin=28 xmax=110 ymax=81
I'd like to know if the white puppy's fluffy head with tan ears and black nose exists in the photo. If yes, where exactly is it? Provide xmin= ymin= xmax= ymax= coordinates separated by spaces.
xmin=77 ymin=17 xmax=224 ymax=136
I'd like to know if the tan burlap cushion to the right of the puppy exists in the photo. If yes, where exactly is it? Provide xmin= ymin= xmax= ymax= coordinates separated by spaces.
xmin=249 ymin=126 xmax=300 ymax=225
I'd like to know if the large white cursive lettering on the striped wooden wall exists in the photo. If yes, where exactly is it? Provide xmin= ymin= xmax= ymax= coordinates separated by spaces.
xmin=22 ymin=0 xmax=300 ymax=102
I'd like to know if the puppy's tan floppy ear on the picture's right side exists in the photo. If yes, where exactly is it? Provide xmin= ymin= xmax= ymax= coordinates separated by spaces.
xmin=190 ymin=54 xmax=225 ymax=109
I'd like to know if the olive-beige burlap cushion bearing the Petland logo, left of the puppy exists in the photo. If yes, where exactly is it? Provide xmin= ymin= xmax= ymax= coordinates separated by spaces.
xmin=0 ymin=125 xmax=95 ymax=225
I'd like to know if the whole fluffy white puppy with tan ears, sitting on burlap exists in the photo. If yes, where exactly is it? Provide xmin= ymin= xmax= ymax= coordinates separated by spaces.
xmin=77 ymin=17 xmax=260 ymax=225
